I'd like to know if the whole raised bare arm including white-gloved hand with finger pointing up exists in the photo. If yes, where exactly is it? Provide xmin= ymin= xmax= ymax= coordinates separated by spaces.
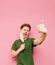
xmin=34 ymin=19 xmax=47 ymax=45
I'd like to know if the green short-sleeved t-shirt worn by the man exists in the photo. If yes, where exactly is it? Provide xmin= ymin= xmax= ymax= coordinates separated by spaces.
xmin=12 ymin=38 xmax=34 ymax=65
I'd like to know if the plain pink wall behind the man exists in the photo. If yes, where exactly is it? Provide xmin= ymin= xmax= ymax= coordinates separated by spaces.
xmin=0 ymin=0 xmax=55 ymax=65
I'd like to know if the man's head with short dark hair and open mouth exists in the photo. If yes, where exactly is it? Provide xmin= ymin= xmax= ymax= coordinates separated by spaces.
xmin=20 ymin=23 xmax=31 ymax=38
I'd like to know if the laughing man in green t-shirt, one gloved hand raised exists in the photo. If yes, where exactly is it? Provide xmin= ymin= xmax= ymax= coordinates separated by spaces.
xmin=11 ymin=21 xmax=47 ymax=65
